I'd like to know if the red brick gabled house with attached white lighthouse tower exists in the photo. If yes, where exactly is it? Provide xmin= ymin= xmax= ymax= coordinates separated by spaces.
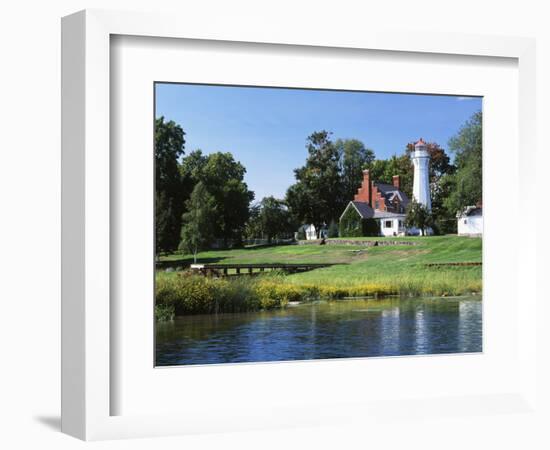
xmin=340 ymin=138 xmax=432 ymax=236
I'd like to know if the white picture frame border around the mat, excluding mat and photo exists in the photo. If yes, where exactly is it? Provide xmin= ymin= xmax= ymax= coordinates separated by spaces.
xmin=62 ymin=10 xmax=537 ymax=440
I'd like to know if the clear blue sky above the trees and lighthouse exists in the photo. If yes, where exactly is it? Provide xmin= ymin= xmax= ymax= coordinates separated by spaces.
xmin=156 ymin=84 xmax=482 ymax=200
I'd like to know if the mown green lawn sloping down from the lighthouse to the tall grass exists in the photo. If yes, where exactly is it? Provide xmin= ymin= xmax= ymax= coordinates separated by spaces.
xmin=163 ymin=236 xmax=482 ymax=294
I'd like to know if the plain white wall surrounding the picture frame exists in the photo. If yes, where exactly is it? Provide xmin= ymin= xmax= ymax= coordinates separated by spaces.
xmin=0 ymin=0 xmax=550 ymax=450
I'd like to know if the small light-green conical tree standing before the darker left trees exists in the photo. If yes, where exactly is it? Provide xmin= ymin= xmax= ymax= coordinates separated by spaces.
xmin=179 ymin=181 xmax=216 ymax=263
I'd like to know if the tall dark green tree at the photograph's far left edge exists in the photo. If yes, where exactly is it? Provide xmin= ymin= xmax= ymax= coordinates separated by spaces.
xmin=155 ymin=117 xmax=185 ymax=255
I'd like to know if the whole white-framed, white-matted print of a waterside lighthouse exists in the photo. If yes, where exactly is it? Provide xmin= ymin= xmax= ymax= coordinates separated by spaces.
xmin=62 ymin=11 xmax=536 ymax=439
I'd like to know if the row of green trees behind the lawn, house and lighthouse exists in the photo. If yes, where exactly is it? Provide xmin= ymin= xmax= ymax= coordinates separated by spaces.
xmin=155 ymin=112 xmax=482 ymax=254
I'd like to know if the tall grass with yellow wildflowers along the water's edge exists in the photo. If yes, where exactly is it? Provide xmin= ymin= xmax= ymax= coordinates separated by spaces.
xmin=155 ymin=270 xmax=482 ymax=320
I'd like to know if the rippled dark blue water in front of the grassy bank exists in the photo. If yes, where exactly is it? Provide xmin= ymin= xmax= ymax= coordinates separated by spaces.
xmin=156 ymin=297 xmax=482 ymax=366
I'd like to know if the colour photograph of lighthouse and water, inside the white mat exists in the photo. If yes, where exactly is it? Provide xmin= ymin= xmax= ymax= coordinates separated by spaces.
xmin=154 ymin=82 xmax=483 ymax=367
